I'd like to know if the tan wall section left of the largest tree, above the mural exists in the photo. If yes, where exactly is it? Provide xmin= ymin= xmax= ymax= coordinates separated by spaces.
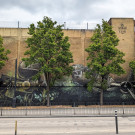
xmin=0 ymin=28 xmax=29 ymax=76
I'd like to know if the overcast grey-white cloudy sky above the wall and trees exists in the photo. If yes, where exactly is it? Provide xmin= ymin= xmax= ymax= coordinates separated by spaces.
xmin=0 ymin=0 xmax=135 ymax=27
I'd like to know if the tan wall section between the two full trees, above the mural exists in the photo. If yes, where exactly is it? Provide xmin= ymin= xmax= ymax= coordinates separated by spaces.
xmin=64 ymin=30 xmax=93 ymax=65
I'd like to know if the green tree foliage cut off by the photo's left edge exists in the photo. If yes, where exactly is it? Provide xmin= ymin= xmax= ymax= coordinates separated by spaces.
xmin=0 ymin=36 xmax=10 ymax=69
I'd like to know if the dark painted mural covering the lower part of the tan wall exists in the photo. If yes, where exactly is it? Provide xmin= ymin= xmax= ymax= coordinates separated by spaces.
xmin=0 ymin=63 xmax=135 ymax=106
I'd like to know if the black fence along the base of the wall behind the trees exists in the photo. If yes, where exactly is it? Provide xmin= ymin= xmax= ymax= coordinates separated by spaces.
xmin=0 ymin=86 xmax=135 ymax=106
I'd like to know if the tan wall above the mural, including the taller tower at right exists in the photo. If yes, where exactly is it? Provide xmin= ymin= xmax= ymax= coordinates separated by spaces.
xmin=0 ymin=18 xmax=135 ymax=81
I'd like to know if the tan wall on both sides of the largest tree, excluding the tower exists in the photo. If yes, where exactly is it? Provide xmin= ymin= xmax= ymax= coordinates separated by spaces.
xmin=0 ymin=28 xmax=93 ymax=75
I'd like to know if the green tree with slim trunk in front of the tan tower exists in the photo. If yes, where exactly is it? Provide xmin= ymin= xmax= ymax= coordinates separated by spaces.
xmin=86 ymin=20 xmax=125 ymax=105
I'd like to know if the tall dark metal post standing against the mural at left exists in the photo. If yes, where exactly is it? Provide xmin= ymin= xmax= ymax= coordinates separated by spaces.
xmin=13 ymin=59 xmax=17 ymax=108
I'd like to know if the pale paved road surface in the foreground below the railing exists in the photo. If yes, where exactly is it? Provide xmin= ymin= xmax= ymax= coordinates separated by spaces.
xmin=0 ymin=117 xmax=135 ymax=135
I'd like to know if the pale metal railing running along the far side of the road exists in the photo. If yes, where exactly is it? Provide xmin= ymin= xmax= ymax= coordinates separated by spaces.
xmin=0 ymin=105 xmax=135 ymax=117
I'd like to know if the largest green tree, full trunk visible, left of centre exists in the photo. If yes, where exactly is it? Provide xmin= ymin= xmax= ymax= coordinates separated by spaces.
xmin=22 ymin=17 xmax=73 ymax=106
